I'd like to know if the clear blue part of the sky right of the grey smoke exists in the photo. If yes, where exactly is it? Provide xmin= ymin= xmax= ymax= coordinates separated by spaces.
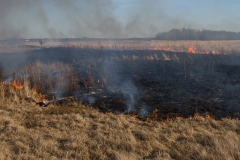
xmin=114 ymin=0 xmax=240 ymax=31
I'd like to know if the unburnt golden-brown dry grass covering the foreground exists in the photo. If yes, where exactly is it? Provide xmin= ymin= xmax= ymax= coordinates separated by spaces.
xmin=0 ymin=86 xmax=240 ymax=160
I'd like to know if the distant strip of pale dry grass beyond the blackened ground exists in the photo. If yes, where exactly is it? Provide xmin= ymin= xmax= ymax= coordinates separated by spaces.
xmin=0 ymin=39 xmax=240 ymax=54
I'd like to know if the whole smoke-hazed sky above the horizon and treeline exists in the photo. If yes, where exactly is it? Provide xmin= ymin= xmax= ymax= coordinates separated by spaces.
xmin=0 ymin=0 xmax=240 ymax=39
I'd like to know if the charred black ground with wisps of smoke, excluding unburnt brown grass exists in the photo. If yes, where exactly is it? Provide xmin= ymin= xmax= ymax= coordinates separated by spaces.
xmin=0 ymin=47 xmax=240 ymax=118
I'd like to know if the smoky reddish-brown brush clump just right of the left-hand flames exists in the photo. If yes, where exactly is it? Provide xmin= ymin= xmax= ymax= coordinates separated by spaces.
xmin=25 ymin=62 xmax=78 ymax=94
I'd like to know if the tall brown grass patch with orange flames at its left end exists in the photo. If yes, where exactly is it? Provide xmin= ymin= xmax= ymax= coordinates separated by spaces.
xmin=0 ymin=61 xmax=79 ymax=103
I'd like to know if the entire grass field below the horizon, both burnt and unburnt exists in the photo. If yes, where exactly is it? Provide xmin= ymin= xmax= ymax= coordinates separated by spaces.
xmin=0 ymin=40 xmax=240 ymax=160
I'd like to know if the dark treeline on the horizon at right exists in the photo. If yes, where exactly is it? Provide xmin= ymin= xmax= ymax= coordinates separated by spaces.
xmin=155 ymin=28 xmax=240 ymax=40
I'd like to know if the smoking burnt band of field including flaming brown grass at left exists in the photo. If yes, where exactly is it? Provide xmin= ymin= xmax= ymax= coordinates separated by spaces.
xmin=0 ymin=48 xmax=240 ymax=119
